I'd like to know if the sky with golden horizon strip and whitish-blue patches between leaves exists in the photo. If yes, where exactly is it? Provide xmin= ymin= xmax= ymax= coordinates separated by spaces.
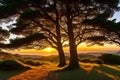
xmin=2 ymin=11 xmax=120 ymax=55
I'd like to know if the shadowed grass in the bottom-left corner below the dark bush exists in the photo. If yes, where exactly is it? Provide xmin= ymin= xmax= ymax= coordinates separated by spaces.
xmin=0 ymin=69 xmax=29 ymax=80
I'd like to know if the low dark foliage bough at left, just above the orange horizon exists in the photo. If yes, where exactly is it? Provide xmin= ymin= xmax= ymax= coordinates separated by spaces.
xmin=0 ymin=33 xmax=47 ymax=50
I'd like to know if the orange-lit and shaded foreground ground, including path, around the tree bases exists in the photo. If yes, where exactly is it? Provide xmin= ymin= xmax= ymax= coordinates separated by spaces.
xmin=9 ymin=62 xmax=120 ymax=80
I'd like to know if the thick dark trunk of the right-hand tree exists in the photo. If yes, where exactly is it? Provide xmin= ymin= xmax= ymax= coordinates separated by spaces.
xmin=67 ymin=19 xmax=79 ymax=69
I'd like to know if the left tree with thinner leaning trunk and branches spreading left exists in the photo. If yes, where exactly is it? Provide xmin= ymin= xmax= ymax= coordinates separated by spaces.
xmin=0 ymin=0 xmax=66 ymax=66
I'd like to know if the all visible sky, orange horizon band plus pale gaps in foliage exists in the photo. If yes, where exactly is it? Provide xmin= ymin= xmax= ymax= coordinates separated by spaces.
xmin=1 ymin=5 xmax=120 ymax=55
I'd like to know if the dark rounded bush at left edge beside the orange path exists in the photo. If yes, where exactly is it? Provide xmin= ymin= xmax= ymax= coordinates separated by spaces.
xmin=0 ymin=60 xmax=28 ymax=70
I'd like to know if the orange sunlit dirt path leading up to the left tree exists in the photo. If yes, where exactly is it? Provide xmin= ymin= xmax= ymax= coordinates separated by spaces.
xmin=8 ymin=64 xmax=58 ymax=80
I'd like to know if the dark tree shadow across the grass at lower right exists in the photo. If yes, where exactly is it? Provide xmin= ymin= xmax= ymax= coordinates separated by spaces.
xmin=40 ymin=65 xmax=120 ymax=80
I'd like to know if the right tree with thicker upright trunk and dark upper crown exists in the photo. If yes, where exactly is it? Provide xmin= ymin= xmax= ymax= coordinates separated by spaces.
xmin=57 ymin=0 xmax=119 ymax=68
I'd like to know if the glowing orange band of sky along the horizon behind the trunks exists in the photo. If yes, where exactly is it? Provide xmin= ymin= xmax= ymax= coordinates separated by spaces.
xmin=4 ymin=43 xmax=120 ymax=55
